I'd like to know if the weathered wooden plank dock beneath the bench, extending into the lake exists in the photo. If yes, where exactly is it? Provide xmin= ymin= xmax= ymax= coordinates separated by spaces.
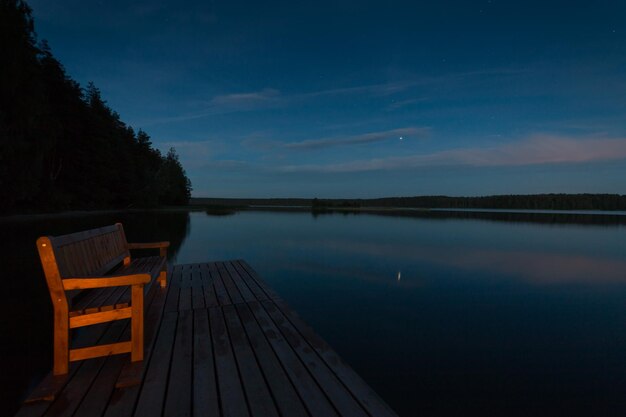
xmin=17 ymin=261 xmax=396 ymax=417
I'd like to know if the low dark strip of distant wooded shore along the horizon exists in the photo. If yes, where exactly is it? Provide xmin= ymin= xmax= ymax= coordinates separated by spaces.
xmin=189 ymin=194 xmax=626 ymax=211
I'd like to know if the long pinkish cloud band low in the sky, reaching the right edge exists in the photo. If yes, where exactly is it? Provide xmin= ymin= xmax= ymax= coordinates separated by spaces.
xmin=281 ymin=135 xmax=626 ymax=173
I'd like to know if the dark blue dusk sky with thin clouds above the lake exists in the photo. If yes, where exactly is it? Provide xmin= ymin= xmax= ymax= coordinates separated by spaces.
xmin=29 ymin=0 xmax=626 ymax=197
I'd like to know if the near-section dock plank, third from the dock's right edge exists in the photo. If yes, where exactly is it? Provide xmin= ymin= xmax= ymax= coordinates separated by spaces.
xmin=248 ymin=301 xmax=338 ymax=417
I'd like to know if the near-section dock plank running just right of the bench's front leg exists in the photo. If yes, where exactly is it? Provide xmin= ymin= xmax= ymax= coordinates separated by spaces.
xmin=133 ymin=312 xmax=178 ymax=417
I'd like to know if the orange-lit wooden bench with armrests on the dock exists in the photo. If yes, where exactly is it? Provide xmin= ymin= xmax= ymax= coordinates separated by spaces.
xmin=37 ymin=223 xmax=169 ymax=375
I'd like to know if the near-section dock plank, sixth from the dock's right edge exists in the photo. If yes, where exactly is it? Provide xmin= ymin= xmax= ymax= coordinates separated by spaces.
xmin=209 ymin=308 xmax=250 ymax=417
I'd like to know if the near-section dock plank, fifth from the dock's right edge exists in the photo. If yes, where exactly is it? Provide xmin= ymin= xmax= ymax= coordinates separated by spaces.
xmin=222 ymin=304 xmax=278 ymax=417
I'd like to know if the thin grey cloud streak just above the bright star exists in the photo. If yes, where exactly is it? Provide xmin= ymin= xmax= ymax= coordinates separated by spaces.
xmin=283 ymin=127 xmax=429 ymax=150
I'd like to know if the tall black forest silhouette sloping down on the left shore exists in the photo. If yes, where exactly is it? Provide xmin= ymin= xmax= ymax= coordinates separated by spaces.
xmin=0 ymin=0 xmax=191 ymax=212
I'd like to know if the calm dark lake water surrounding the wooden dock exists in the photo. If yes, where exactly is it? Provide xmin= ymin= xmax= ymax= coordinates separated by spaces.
xmin=0 ymin=212 xmax=626 ymax=416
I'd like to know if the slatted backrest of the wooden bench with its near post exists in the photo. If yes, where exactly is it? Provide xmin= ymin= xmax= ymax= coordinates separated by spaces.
xmin=37 ymin=223 xmax=130 ymax=304
